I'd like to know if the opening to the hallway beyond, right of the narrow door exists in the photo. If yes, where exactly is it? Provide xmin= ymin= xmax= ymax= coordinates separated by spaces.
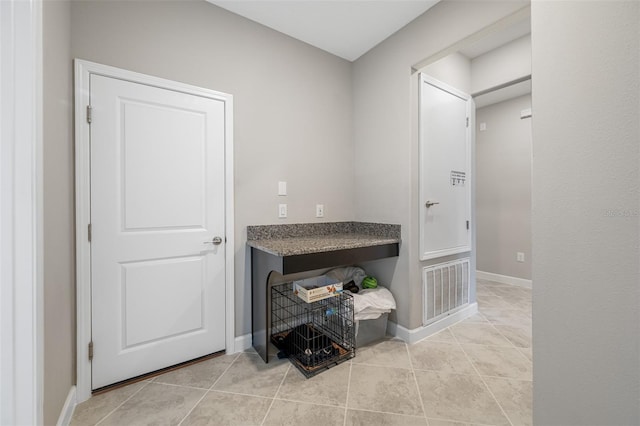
xmin=414 ymin=8 xmax=532 ymax=344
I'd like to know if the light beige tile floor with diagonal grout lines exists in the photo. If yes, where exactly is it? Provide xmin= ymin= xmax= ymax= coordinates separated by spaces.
xmin=71 ymin=280 xmax=532 ymax=426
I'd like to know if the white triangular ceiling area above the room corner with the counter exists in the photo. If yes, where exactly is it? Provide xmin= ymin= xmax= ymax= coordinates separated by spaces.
xmin=207 ymin=0 xmax=439 ymax=61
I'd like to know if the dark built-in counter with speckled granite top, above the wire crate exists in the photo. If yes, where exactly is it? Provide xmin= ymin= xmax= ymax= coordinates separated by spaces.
xmin=247 ymin=222 xmax=400 ymax=362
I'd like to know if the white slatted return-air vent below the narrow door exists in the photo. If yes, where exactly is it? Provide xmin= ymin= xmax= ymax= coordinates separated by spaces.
xmin=422 ymin=258 xmax=469 ymax=325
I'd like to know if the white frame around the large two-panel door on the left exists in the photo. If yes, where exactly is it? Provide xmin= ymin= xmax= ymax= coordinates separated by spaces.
xmin=75 ymin=59 xmax=235 ymax=403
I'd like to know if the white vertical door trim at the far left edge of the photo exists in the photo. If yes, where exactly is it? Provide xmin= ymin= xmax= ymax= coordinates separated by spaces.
xmin=0 ymin=0 xmax=44 ymax=425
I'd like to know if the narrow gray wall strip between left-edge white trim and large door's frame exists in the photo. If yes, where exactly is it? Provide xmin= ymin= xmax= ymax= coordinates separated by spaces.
xmin=43 ymin=1 xmax=76 ymax=425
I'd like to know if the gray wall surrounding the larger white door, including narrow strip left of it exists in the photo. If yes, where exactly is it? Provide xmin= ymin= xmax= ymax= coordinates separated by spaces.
xmin=43 ymin=0 xmax=354 ymax=424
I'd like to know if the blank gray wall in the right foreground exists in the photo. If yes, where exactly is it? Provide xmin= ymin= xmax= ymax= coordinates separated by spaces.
xmin=532 ymin=1 xmax=640 ymax=425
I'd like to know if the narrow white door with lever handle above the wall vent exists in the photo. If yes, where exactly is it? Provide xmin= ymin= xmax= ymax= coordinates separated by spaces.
xmin=420 ymin=74 xmax=472 ymax=260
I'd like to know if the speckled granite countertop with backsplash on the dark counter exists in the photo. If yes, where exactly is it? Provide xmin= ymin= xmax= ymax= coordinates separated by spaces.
xmin=247 ymin=222 xmax=400 ymax=257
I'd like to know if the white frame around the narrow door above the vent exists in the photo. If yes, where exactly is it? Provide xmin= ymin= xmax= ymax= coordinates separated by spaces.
xmin=418 ymin=72 xmax=475 ymax=261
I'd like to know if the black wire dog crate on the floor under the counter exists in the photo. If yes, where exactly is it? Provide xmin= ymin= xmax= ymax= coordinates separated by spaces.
xmin=271 ymin=283 xmax=356 ymax=378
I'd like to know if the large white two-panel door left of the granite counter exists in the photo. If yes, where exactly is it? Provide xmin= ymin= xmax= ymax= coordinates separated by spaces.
xmin=90 ymin=74 xmax=225 ymax=389
